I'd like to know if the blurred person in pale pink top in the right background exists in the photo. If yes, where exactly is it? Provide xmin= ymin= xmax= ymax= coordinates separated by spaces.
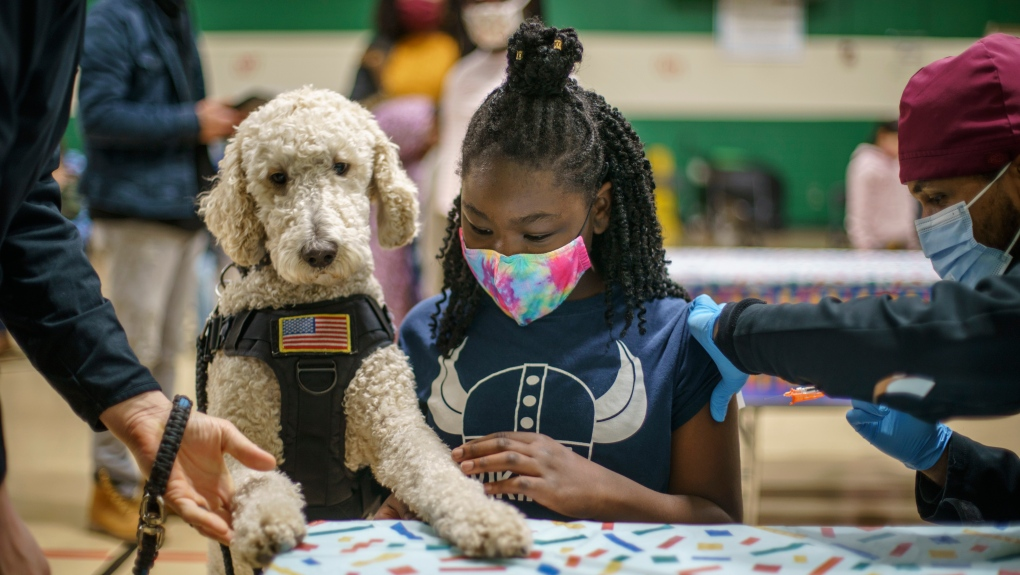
xmin=846 ymin=120 xmax=919 ymax=250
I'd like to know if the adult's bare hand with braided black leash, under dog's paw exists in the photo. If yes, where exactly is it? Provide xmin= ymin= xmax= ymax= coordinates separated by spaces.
xmin=99 ymin=391 xmax=276 ymax=543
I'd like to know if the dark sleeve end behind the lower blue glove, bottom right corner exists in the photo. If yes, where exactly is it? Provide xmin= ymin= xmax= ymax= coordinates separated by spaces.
xmin=914 ymin=432 xmax=1020 ymax=523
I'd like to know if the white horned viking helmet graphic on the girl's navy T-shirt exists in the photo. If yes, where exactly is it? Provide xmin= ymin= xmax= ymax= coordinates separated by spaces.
xmin=428 ymin=339 xmax=648 ymax=458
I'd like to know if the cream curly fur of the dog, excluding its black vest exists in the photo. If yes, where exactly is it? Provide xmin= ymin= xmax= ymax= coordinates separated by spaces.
xmin=200 ymin=88 xmax=531 ymax=573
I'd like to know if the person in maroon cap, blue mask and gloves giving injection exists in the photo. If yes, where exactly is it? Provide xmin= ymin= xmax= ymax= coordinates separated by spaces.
xmin=689 ymin=34 xmax=1020 ymax=522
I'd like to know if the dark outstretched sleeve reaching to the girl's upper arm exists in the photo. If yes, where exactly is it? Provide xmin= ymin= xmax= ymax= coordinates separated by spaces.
xmin=716 ymin=269 xmax=1020 ymax=420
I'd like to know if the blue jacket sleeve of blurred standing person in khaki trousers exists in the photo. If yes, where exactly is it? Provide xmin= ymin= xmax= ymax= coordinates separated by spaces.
xmin=78 ymin=4 xmax=199 ymax=150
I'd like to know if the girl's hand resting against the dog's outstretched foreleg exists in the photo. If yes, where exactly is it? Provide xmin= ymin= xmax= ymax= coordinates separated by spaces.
xmin=453 ymin=431 xmax=610 ymax=519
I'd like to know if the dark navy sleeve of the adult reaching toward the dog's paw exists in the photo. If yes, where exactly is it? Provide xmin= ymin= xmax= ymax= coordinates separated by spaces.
xmin=0 ymin=157 xmax=159 ymax=430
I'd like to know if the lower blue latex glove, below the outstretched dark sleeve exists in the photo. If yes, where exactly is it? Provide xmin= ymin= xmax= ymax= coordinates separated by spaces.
xmin=847 ymin=400 xmax=953 ymax=470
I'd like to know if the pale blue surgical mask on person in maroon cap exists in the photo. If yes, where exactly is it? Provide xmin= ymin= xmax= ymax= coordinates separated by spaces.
xmin=914 ymin=164 xmax=1020 ymax=288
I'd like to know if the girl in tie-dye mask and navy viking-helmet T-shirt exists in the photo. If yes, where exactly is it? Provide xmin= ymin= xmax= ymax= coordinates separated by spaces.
xmin=377 ymin=20 xmax=742 ymax=523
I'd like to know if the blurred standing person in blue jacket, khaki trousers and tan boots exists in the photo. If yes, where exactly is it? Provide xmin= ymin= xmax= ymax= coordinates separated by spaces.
xmin=79 ymin=0 xmax=241 ymax=540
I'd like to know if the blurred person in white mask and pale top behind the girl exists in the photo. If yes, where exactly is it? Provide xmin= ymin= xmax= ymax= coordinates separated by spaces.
xmin=419 ymin=0 xmax=542 ymax=298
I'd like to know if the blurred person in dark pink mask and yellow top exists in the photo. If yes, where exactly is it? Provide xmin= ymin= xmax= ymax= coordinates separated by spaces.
xmin=351 ymin=0 xmax=471 ymax=104
